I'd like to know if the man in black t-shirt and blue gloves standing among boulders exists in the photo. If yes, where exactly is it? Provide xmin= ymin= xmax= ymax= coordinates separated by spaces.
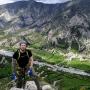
xmin=12 ymin=41 xmax=41 ymax=90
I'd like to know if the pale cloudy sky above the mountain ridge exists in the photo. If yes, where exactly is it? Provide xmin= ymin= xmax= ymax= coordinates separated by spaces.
xmin=0 ymin=0 xmax=69 ymax=5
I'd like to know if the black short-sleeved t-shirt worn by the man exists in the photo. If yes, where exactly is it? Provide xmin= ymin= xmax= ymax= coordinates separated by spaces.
xmin=13 ymin=49 xmax=32 ymax=68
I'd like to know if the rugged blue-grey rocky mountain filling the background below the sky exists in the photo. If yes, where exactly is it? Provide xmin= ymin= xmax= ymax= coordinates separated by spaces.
xmin=0 ymin=0 xmax=90 ymax=52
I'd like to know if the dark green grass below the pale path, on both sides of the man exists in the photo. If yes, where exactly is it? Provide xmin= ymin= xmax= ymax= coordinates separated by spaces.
xmin=0 ymin=60 xmax=90 ymax=90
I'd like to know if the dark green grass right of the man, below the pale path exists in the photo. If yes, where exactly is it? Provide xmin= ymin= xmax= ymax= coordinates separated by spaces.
xmin=35 ymin=67 xmax=90 ymax=90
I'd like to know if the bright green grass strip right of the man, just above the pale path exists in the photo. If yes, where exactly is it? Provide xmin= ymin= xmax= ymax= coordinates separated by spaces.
xmin=32 ymin=49 xmax=90 ymax=72
